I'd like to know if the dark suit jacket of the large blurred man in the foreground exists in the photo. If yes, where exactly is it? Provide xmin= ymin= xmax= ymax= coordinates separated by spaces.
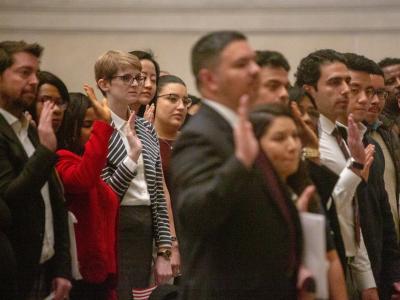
xmin=170 ymin=105 xmax=301 ymax=300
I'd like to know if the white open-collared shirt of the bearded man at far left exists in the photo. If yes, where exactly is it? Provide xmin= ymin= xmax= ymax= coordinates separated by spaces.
xmin=0 ymin=108 xmax=54 ymax=263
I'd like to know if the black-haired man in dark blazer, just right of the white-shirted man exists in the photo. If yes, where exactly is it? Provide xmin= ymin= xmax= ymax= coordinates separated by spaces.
xmin=338 ymin=53 xmax=400 ymax=299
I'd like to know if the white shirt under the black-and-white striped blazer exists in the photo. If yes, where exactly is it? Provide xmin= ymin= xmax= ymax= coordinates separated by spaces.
xmin=111 ymin=112 xmax=150 ymax=206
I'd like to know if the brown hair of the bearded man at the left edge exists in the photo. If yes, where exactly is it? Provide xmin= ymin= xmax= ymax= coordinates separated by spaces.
xmin=0 ymin=41 xmax=43 ymax=74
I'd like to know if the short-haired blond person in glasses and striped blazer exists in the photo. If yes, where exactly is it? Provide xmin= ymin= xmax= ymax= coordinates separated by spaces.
xmin=95 ymin=51 xmax=172 ymax=299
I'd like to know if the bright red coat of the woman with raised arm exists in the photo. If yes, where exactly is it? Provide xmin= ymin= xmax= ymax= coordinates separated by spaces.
xmin=56 ymin=121 xmax=119 ymax=283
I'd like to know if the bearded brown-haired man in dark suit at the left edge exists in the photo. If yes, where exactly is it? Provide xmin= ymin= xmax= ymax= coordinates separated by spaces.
xmin=0 ymin=41 xmax=71 ymax=300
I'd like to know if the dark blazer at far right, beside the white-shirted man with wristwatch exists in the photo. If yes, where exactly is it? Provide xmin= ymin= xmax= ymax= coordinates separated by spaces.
xmin=357 ymin=137 xmax=400 ymax=299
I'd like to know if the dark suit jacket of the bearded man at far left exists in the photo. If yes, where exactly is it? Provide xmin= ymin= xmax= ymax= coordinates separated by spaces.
xmin=0 ymin=115 xmax=71 ymax=299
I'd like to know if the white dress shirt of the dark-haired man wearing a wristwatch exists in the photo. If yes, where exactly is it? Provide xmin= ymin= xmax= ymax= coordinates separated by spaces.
xmin=319 ymin=114 xmax=376 ymax=291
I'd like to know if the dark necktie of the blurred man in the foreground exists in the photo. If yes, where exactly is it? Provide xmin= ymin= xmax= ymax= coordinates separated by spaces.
xmin=255 ymin=153 xmax=299 ymax=271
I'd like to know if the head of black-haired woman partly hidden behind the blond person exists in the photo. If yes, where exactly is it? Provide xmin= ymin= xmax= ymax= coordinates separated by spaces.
xmin=129 ymin=50 xmax=160 ymax=123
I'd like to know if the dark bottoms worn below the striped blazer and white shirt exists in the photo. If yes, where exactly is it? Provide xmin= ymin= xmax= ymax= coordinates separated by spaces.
xmin=117 ymin=206 xmax=153 ymax=300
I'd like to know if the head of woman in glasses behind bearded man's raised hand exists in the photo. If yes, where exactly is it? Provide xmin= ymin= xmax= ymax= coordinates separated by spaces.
xmin=29 ymin=71 xmax=69 ymax=133
